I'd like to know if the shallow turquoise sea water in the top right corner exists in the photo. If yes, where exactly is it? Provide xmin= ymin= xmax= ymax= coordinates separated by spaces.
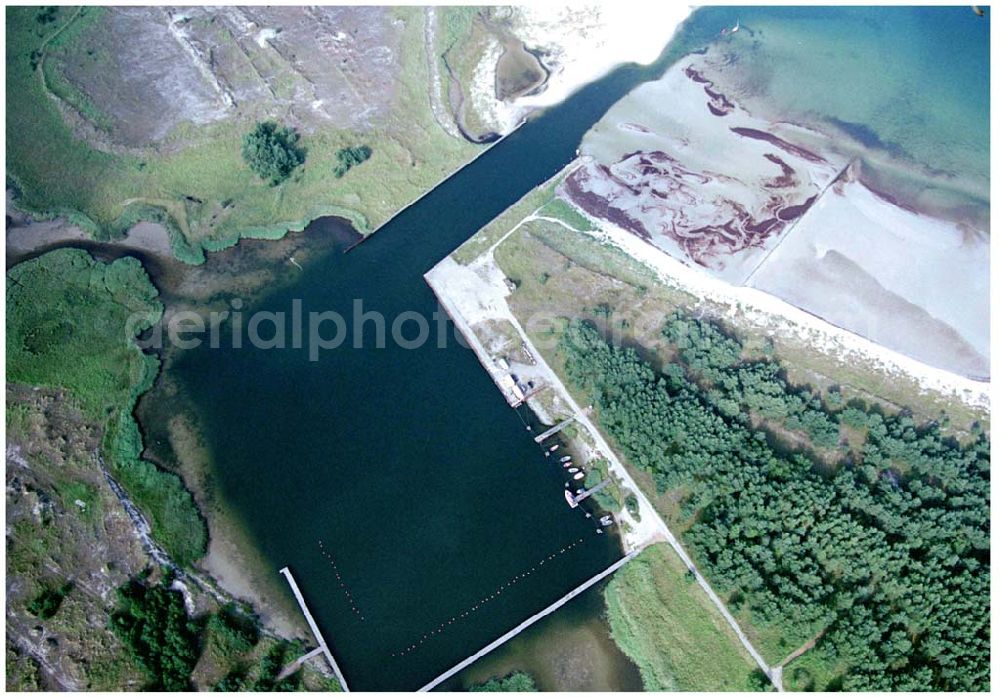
xmin=695 ymin=6 xmax=990 ymax=212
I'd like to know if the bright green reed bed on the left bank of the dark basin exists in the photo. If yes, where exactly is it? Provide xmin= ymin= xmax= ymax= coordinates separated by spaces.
xmin=6 ymin=249 xmax=207 ymax=565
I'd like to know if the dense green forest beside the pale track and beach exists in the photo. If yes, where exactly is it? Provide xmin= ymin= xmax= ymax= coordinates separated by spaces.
xmin=560 ymin=314 xmax=990 ymax=690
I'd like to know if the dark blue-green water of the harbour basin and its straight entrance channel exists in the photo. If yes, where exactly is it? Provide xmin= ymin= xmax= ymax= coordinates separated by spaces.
xmin=175 ymin=19 xmax=728 ymax=690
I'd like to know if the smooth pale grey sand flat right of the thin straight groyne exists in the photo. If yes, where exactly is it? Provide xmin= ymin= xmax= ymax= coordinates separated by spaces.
xmin=747 ymin=173 xmax=990 ymax=379
